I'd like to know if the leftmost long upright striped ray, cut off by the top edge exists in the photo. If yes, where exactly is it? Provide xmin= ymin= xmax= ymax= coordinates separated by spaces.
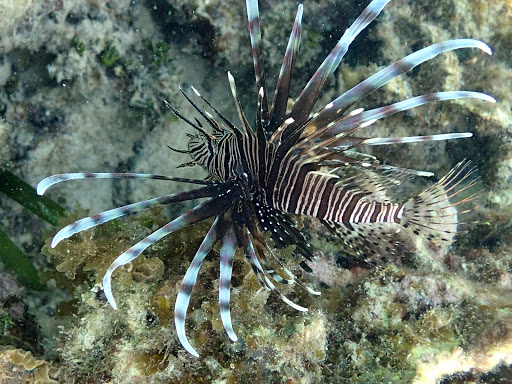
xmin=245 ymin=0 xmax=268 ymax=126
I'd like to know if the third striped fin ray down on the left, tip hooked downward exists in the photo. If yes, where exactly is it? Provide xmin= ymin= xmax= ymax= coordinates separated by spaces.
xmin=103 ymin=195 xmax=231 ymax=309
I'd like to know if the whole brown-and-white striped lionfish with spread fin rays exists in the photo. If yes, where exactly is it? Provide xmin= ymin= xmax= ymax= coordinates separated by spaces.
xmin=37 ymin=0 xmax=495 ymax=357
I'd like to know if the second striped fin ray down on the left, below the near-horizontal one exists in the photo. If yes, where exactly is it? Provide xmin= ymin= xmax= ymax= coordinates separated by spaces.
xmin=51 ymin=186 xmax=225 ymax=248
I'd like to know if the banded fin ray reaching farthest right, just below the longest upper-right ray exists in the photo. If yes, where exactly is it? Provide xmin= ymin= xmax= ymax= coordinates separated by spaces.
xmin=310 ymin=91 xmax=496 ymax=150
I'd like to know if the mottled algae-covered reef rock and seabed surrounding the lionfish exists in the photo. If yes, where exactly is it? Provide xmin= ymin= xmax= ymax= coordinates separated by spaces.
xmin=0 ymin=0 xmax=512 ymax=384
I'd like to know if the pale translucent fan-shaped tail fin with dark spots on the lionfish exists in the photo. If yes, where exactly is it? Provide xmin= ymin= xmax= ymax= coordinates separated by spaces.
xmin=400 ymin=160 xmax=479 ymax=243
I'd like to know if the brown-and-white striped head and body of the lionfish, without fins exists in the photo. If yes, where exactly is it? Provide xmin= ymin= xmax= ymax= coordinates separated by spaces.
xmin=189 ymin=126 xmax=403 ymax=228
